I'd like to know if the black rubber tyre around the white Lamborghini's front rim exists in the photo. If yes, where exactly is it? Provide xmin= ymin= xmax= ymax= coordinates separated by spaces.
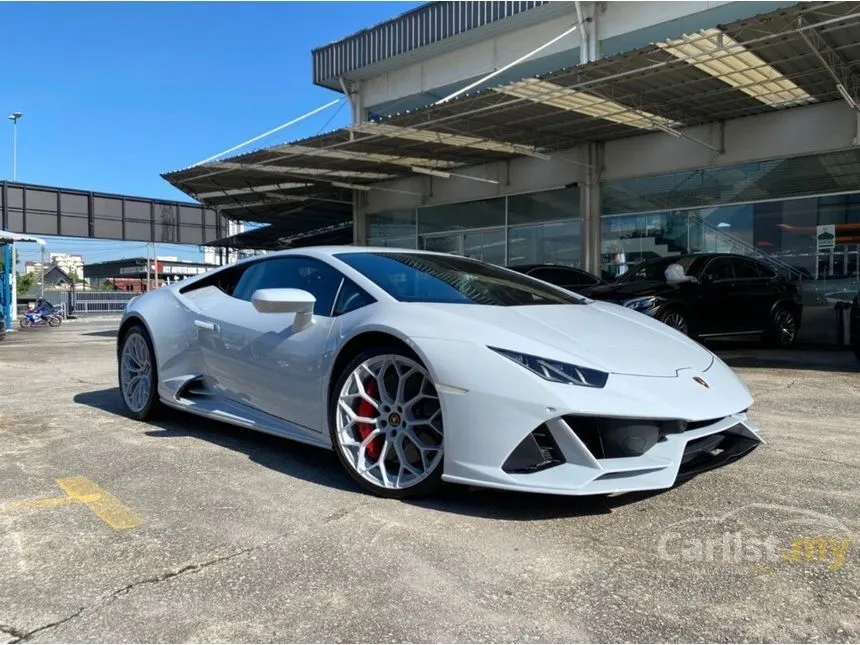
xmin=328 ymin=345 xmax=444 ymax=499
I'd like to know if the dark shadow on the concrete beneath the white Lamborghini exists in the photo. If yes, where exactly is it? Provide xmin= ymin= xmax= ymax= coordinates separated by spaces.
xmin=73 ymin=387 xmax=662 ymax=521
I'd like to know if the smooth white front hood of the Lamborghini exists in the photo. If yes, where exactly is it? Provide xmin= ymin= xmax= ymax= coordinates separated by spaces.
xmin=408 ymin=302 xmax=714 ymax=377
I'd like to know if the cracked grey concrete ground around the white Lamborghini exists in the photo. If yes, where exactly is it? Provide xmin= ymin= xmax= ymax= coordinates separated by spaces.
xmin=0 ymin=321 xmax=860 ymax=643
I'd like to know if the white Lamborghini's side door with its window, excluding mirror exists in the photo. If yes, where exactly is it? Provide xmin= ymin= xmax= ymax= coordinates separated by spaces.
xmin=198 ymin=256 xmax=343 ymax=431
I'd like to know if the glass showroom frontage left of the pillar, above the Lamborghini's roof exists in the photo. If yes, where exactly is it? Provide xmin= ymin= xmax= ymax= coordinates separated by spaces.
xmin=368 ymin=187 xmax=582 ymax=266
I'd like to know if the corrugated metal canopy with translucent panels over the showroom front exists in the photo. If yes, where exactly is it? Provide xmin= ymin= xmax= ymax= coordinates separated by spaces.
xmin=163 ymin=2 xmax=860 ymax=250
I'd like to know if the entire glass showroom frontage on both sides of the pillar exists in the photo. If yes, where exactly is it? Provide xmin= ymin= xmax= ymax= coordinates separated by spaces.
xmin=368 ymin=150 xmax=860 ymax=293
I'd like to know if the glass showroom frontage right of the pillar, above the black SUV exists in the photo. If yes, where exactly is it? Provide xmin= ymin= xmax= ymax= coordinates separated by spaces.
xmin=601 ymin=150 xmax=860 ymax=280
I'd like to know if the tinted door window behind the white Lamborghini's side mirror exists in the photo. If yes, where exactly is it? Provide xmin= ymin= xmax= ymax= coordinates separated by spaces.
xmin=233 ymin=257 xmax=343 ymax=316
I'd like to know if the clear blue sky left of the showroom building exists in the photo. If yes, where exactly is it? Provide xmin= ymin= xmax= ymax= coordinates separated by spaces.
xmin=0 ymin=2 xmax=421 ymax=262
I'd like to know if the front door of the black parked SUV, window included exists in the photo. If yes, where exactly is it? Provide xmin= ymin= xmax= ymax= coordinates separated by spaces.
xmin=691 ymin=255 xmax=742 ymax=335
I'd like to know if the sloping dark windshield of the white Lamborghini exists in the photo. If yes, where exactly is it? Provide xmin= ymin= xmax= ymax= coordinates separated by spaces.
xmin=336 ymin=252 xmax=583 ymax=307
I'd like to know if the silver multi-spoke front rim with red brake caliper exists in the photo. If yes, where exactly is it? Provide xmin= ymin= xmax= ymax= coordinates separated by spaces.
xmin=335 ymin=354 xmax=443 ymax=490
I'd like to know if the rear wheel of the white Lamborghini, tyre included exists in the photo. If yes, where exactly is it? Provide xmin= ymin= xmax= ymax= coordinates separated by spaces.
xmin=119 ymin=325 xmax=159 ymax=421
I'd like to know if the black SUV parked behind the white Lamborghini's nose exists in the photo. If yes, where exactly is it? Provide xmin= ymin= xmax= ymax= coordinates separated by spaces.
xmin=583 ymin=253 xmax=803 ymax=347
